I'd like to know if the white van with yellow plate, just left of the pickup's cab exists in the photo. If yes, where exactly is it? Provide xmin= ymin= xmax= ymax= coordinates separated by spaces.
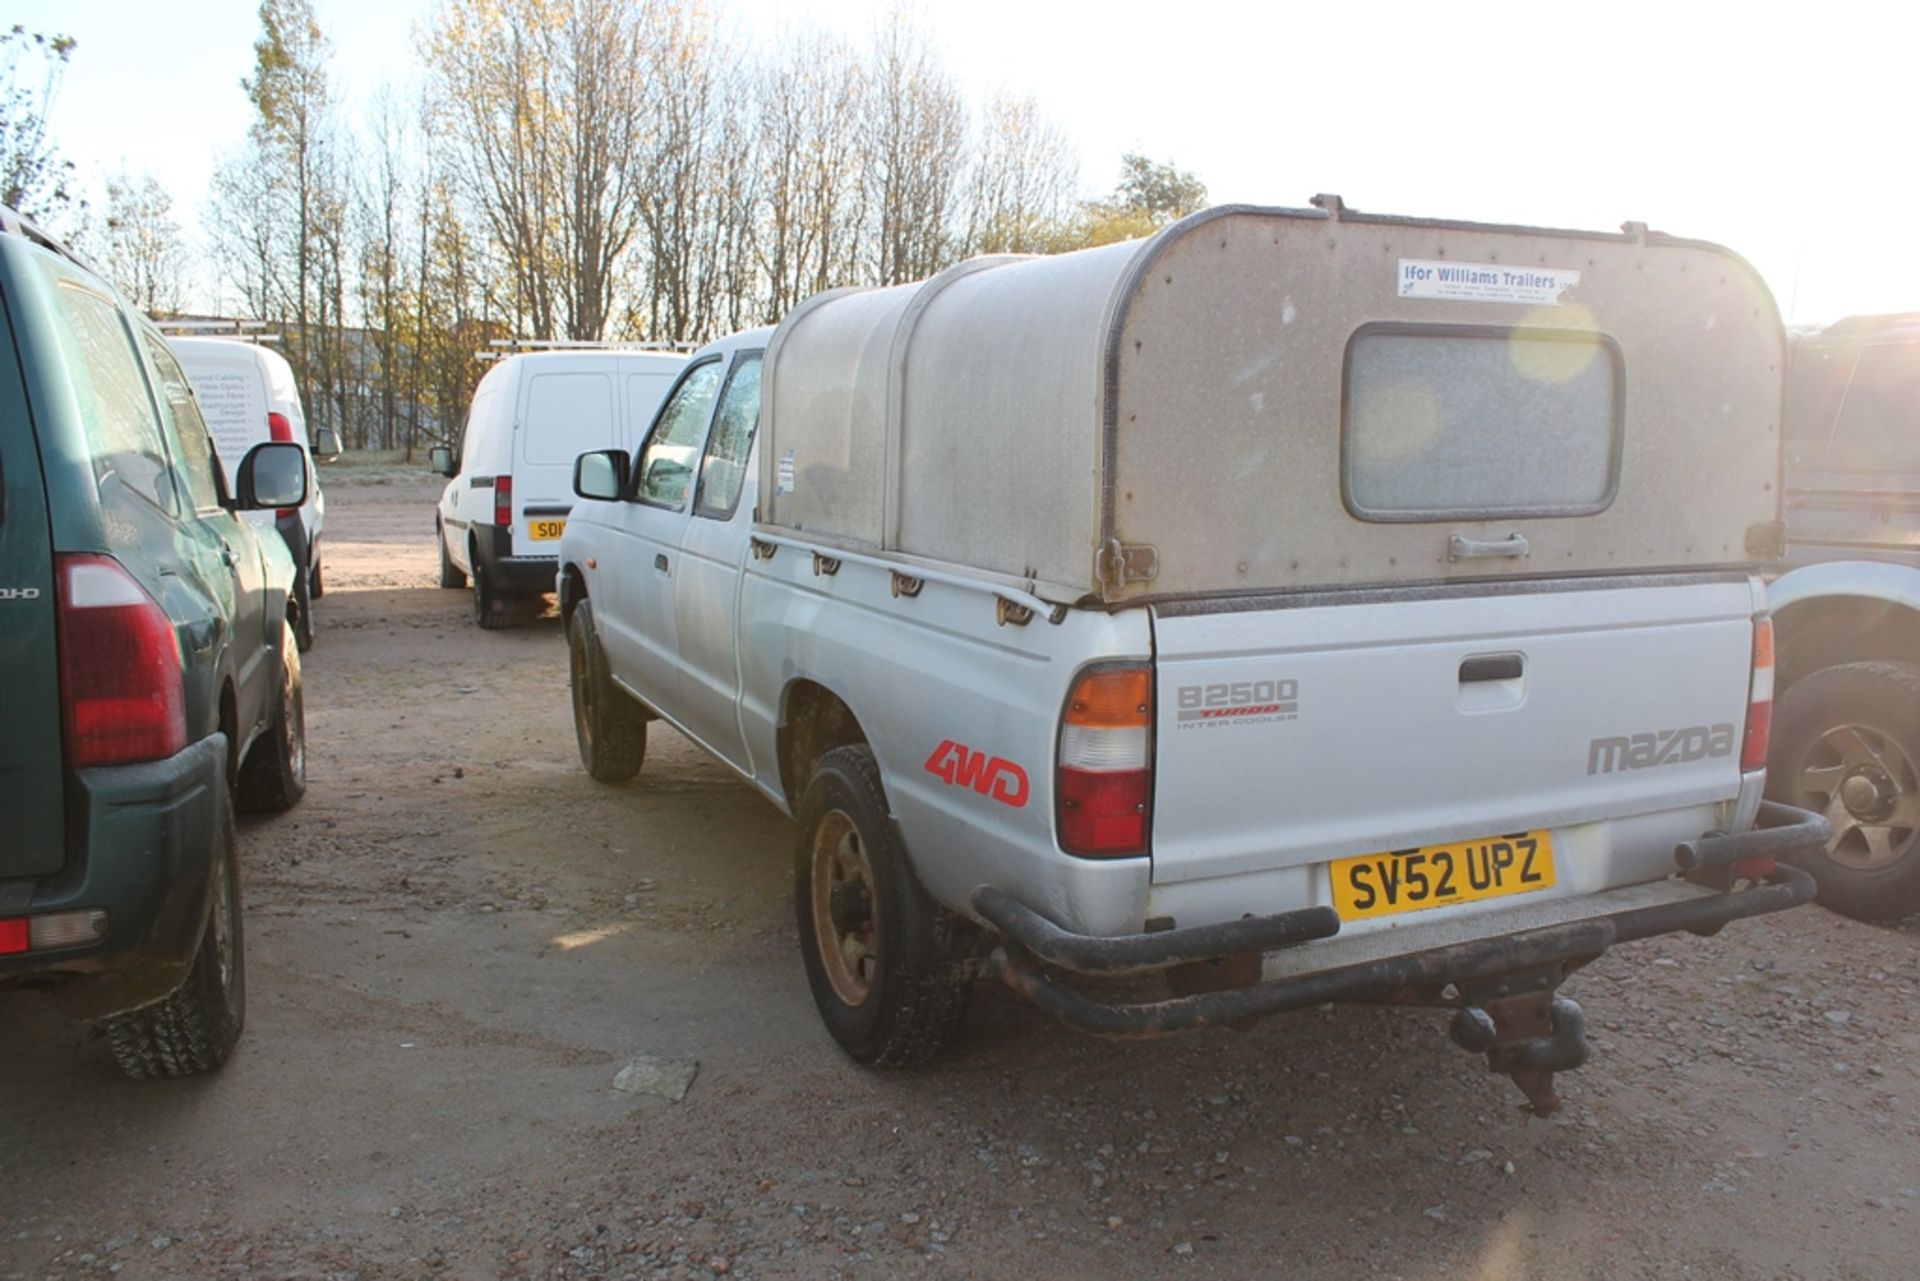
xmin=430 ymin=350 xmax=687 ymax=628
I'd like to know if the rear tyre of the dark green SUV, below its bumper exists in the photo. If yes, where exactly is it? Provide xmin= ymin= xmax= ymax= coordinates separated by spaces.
xmin=108 ymin=791 xmax=246 ymax=1077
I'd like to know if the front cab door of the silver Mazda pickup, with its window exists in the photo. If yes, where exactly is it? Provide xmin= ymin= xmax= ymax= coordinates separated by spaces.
xmin=593 ymin=357 xmax=726 ymax=720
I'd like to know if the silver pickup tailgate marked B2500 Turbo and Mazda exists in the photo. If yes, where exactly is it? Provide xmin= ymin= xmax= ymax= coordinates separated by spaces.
xmin=1152 ymin=576 xmax=1755 ymax=883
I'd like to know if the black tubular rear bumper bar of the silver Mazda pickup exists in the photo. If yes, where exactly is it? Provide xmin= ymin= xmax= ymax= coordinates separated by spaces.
xmin=973 ymin=803 xmax=1832 ymax=1037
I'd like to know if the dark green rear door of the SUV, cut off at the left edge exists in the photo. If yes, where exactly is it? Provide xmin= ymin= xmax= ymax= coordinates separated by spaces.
xmin=0 ymin=280 xmax=65 ymax=882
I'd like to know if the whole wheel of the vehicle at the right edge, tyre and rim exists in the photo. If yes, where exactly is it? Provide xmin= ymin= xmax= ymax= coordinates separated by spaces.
xmin=1766 ymin=663 xmax=1920 ymax=920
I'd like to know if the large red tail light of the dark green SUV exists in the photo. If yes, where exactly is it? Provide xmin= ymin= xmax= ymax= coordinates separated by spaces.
xmin=54 ymin=553 xmax=186 ymax=768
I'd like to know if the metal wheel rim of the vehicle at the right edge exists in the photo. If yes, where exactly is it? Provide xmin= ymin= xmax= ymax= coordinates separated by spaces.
xmin=1797 ymin=724 xmax=1920 ymax=872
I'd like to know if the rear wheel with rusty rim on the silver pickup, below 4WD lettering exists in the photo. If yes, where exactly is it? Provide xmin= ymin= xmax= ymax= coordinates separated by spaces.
xmin=793 ymin=745 xmax=973 ymax=1068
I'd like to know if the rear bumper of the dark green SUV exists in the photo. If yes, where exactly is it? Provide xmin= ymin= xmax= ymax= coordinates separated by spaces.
xmin=0 ymin=734 xmax=227 ymax=1018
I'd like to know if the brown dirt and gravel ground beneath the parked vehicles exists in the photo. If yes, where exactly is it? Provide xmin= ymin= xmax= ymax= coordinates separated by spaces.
xmin=0 ymin=469 xmax=1920 ymax=1279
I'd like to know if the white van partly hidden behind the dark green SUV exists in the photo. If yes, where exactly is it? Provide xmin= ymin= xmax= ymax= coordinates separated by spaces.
xmin=167 ymin=338 xmax=340 ymax=651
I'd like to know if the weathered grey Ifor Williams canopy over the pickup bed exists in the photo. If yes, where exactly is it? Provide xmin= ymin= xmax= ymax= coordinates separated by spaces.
xmin=758 ymin=198 xmax=1786 ymax=603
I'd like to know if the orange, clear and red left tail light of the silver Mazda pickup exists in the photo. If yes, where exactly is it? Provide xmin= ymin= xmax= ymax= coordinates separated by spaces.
xmin=1054 ymin=665 xmax=1154 ymax=858
